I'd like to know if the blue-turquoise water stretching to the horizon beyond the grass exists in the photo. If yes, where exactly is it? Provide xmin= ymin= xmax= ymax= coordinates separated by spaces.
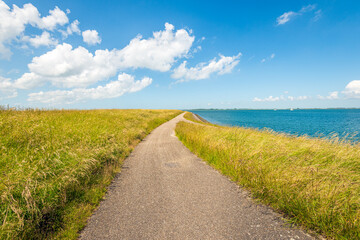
xmin=190 ymin=109 xmax=360 ymax=141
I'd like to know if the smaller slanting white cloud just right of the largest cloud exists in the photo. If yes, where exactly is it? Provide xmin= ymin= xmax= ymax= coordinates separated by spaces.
xmin=171 ymin=53 xmax=241 ymax=82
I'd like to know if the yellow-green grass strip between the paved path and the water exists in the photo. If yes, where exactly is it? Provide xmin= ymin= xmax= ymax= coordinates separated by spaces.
xmin=176 ymin=114 xmax=360 ymax=239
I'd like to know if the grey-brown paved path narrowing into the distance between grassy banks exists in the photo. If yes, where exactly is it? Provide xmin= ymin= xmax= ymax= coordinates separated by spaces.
xmin=80 ymin=114 xmax=312 ymax=240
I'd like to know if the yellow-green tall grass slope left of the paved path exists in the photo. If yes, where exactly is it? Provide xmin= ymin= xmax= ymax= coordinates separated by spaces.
xmin=0 ymin=110 xmax=180 ymax=239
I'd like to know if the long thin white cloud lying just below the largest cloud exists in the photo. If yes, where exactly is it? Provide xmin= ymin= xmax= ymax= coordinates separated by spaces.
xmin=28 ymin=73 xmax=152 ymax=104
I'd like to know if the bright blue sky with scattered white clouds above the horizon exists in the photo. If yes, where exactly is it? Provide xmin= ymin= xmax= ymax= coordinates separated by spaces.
xmin=0 ymin=0 xmax=360 ymax=109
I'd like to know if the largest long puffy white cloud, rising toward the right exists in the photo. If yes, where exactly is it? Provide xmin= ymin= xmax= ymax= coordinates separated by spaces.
xmin=15 ymin=23 xmax=194 ymax=89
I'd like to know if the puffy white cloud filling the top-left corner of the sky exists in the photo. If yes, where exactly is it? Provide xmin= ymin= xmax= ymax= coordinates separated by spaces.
xmin=0 ymin=0 xmax=69 ymax=59
